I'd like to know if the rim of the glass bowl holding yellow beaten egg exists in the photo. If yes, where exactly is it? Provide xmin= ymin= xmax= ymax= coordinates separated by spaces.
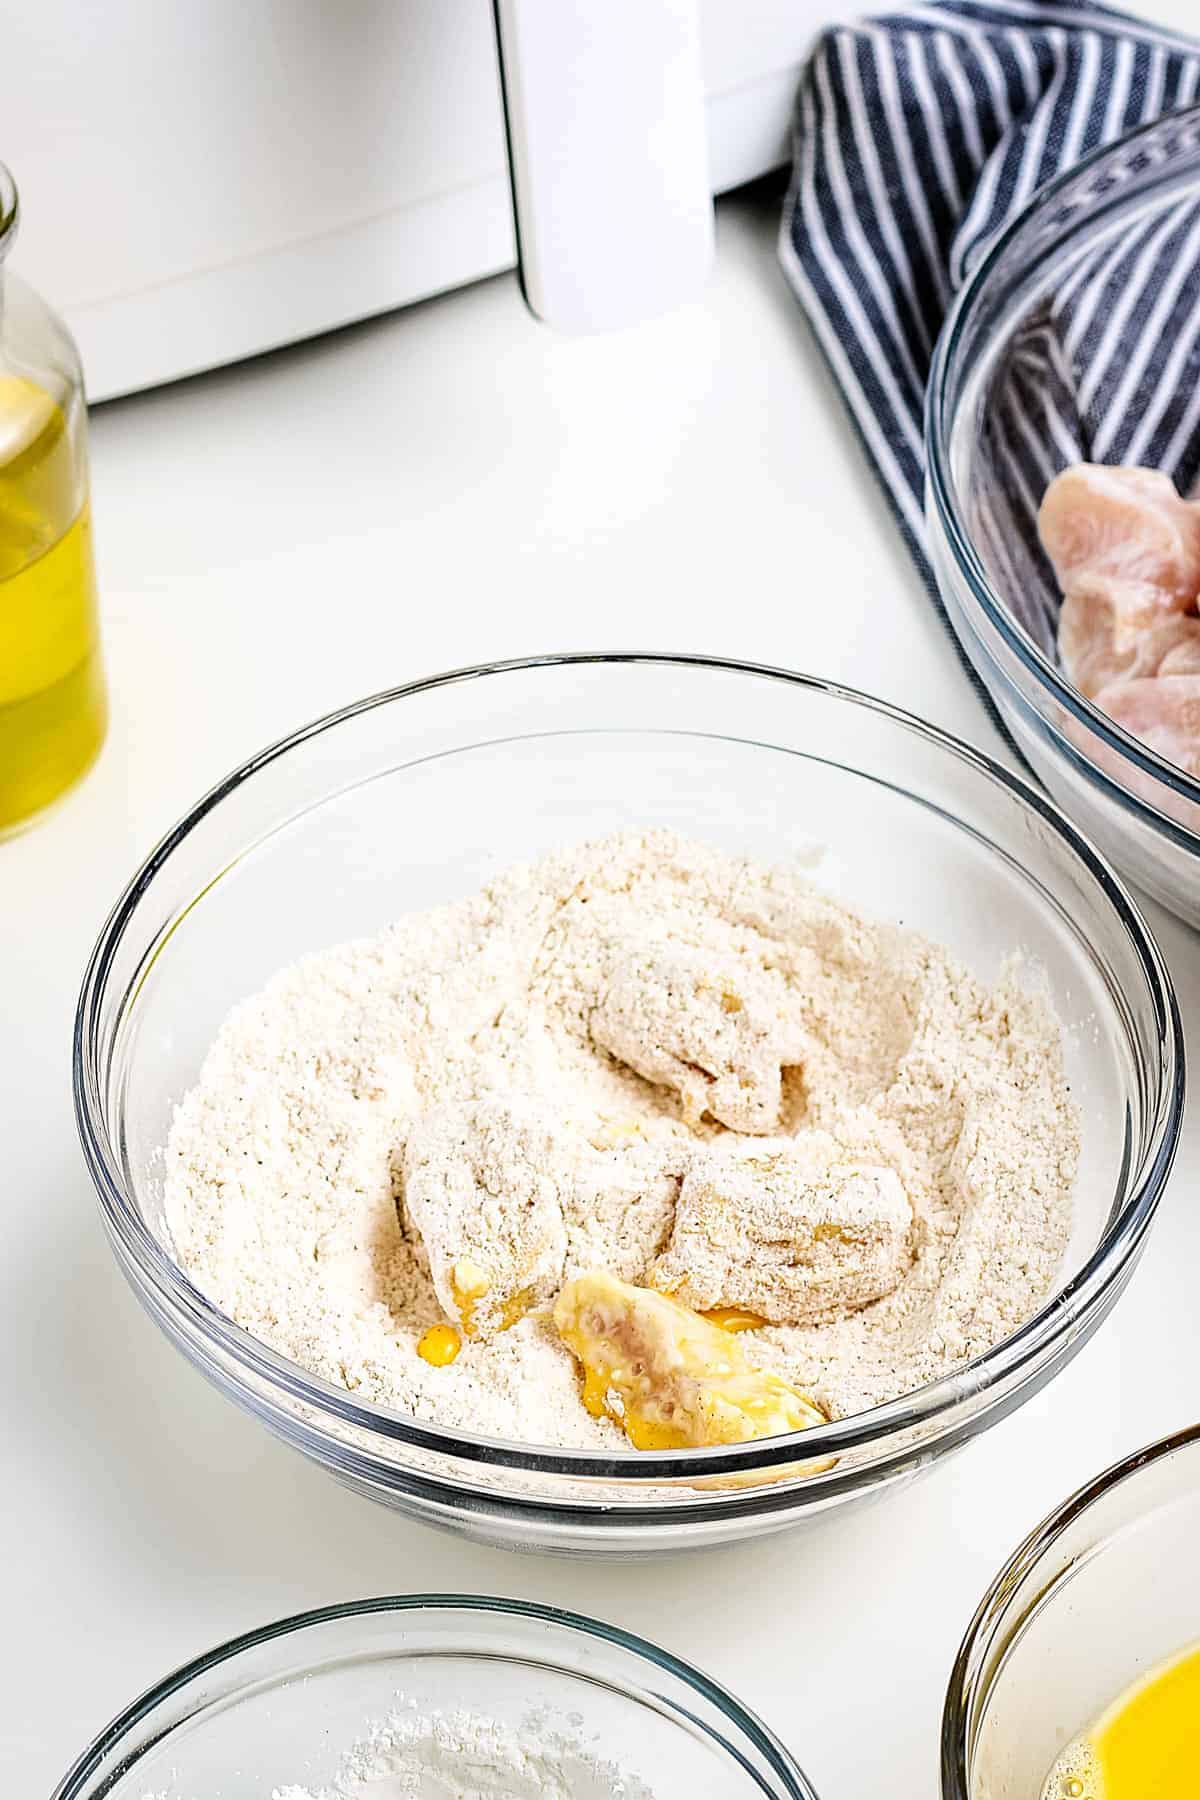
xmin=941 ymin=1424 xmax=1200 ymax=1800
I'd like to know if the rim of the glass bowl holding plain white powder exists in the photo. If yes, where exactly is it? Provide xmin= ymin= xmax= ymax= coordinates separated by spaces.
xmin=50 ymin=1593 xmax=817 ymax=1800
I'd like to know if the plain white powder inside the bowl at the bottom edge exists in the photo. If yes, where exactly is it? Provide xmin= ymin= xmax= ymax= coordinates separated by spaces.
xmin=272 ymin=1710 xmax=653 ymax=1800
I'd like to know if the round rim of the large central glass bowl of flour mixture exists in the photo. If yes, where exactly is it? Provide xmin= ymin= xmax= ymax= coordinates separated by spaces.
xmin=72 ymin=652 xmax=1186 ymax=1483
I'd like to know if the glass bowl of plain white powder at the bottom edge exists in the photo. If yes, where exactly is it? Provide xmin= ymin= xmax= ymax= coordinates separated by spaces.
xmin=52 ymin=1595 xmax=817 ymax=1800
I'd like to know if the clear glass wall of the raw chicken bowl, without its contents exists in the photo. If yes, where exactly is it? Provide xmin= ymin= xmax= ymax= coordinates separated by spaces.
xmin=925 ymin=108 xmax=1200 ymax=925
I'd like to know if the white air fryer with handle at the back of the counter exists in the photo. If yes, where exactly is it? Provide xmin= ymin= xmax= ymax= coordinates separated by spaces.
xmin=0 ymin=0 xmax=863 ymax=398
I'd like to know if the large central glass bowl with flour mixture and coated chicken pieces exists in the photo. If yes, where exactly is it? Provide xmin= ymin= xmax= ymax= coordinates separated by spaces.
xmin=74 ymin=655 xmax=1184 ymax=1555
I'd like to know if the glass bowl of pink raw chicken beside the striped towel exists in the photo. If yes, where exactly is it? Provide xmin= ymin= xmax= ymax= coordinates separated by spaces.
xmin=927 ymin=108 xmax=1200 ymax=923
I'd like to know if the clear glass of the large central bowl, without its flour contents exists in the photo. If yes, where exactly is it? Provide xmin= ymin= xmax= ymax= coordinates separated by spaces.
xmin=74 ymin=655 xmax=1184 ymax=1555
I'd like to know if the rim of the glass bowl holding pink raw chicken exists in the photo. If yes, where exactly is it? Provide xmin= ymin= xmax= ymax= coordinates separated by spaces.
xmin=925 ymin=101 xmax=1200 ymax=855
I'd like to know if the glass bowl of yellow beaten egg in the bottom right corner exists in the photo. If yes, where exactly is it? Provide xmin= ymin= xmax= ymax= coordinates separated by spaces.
xmin=941 ymin=1427 xmax=1200 ymax=1800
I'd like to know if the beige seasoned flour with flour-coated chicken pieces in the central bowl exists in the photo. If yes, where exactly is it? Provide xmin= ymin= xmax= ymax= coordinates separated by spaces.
xmin=166 ymin=832 xmax=1078 ymax=1447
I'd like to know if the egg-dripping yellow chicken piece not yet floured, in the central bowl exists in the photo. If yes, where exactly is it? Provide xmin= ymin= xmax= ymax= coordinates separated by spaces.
xmin=554 ymin=1271 xmax=824 ymax=1451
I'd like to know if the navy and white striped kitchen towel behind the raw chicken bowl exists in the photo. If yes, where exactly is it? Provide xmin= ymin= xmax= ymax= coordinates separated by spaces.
xmin=781 ymin=0 xmax=1200 ymax=716
